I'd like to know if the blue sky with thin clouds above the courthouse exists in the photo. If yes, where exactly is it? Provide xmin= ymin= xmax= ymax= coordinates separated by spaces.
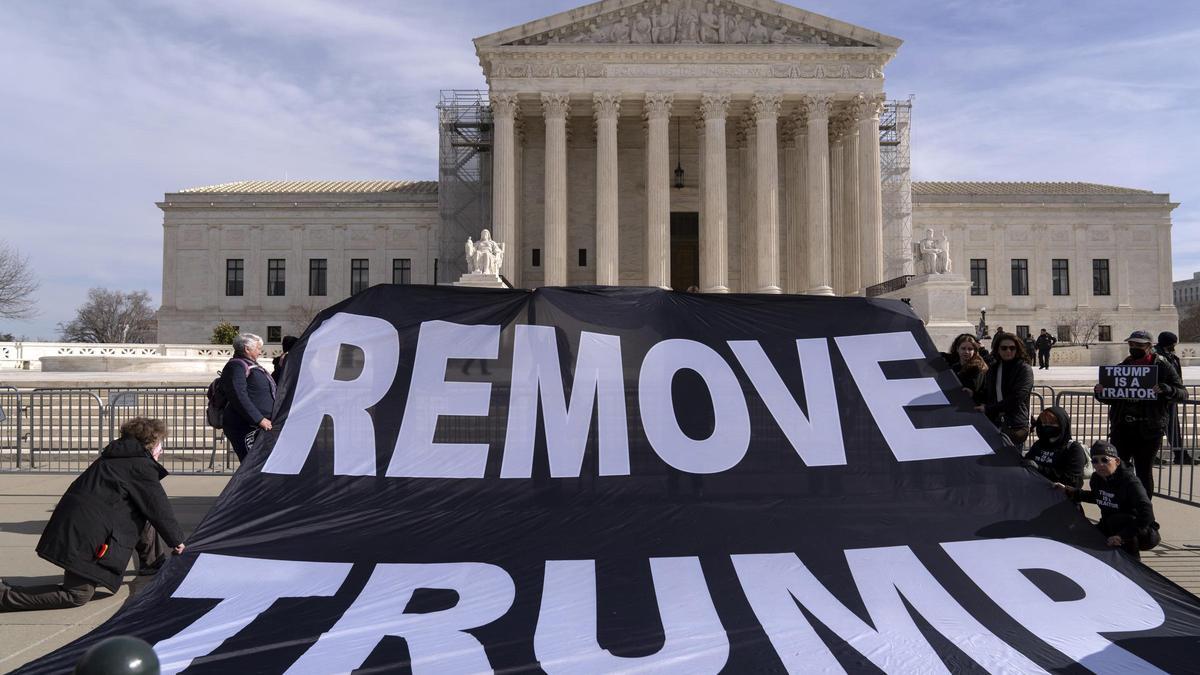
xmin=0 ymin=0 xmax=1200 ymax=339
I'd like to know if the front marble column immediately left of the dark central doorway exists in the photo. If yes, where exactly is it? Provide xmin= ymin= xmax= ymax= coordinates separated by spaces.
xmin=643 ymin=94 xmax=674 ymax=288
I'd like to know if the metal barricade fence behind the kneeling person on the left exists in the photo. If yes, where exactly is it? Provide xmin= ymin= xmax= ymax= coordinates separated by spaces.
xmin=0 ymin=387 xmax=238 ymax=473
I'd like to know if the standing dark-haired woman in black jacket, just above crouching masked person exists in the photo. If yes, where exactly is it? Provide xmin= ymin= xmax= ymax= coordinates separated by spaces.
xmin=983 ymin=333 xmax=1033 ymax=447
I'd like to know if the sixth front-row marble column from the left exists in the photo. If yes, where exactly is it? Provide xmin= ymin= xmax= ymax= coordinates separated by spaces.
xmin=750 ymin=94 xmax=782 ymax=293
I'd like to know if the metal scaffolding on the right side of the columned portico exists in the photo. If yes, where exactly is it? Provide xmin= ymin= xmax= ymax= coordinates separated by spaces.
xmin=880 ymin=96 xmax=913 ymax=279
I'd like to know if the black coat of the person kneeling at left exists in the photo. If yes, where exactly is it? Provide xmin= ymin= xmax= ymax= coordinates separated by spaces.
xmin=37 ymin=436 xmax=184 ymax=592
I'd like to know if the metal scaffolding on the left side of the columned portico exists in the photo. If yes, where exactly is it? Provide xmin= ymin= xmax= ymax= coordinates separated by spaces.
xmin=436 ymin=89 xmax=492 ymax=283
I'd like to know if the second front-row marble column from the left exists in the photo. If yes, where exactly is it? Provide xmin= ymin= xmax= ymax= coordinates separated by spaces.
xmin=541 ymin=94 xmax=570 ymax=286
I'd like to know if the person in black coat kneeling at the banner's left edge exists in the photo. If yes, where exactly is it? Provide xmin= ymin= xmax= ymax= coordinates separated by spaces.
xmin=0 ymin=417 xmax=184 ymax=611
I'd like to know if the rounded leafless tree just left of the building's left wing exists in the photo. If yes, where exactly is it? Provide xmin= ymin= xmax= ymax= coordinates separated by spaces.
xmin=59 ymin=288 xmax=157 ymax=342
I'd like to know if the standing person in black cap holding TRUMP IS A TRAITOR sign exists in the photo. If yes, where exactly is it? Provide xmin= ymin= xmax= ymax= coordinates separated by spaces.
xmin=1096 ymin=330 xmax=1188 ymax=496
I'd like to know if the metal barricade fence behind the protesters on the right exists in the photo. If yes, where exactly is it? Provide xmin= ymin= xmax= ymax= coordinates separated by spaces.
xmin=1055 ymin=386 xmax=1200 ymax=506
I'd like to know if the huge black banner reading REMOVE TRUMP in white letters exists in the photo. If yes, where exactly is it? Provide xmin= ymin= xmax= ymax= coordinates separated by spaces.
xmin=18 ymin=286 xmax=1200 ymax=674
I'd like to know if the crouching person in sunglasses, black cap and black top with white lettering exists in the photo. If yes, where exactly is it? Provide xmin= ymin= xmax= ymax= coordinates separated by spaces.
xmin=1052 ymin=441 xmax=1162 ymax=557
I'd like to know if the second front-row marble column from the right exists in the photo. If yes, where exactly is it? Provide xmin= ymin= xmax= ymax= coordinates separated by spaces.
xmin=804 ymin=96 xmax=833 ymax=295
